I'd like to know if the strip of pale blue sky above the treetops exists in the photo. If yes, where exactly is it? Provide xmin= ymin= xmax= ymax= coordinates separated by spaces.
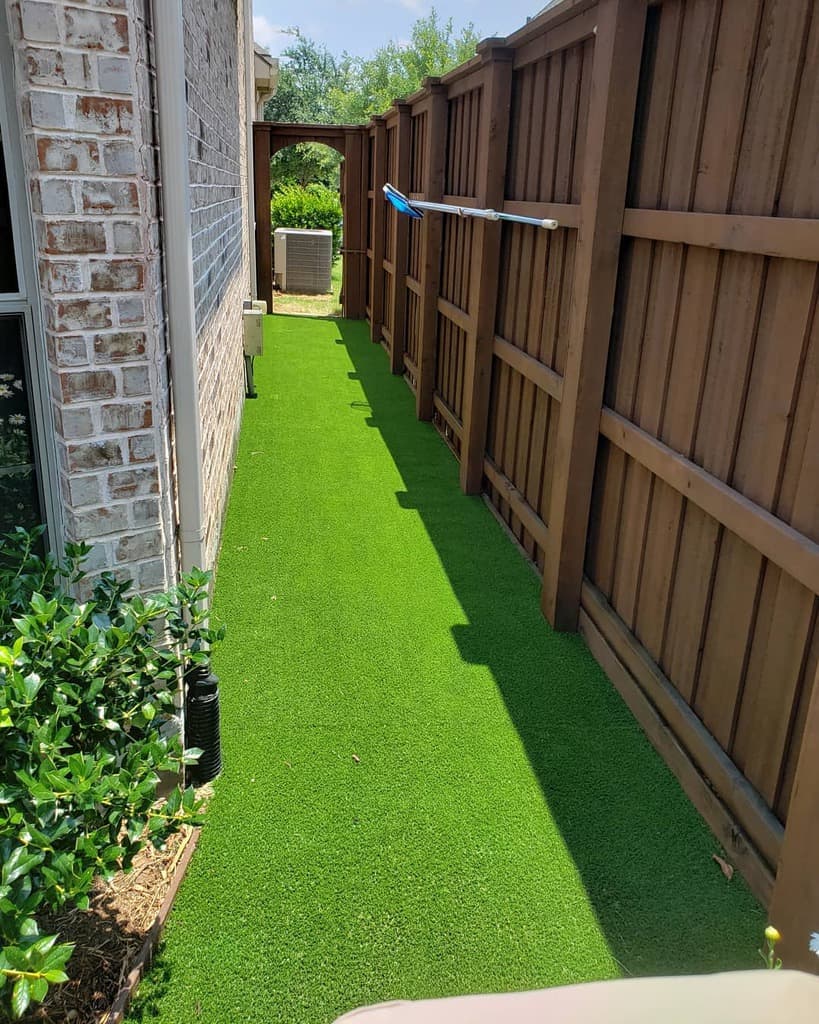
xmin=253 ymin=0 xmax=547 ymax=56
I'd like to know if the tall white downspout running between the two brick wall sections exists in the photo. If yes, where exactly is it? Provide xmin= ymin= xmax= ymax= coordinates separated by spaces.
xmin=153 ymin=0 xmax=207 ymax=572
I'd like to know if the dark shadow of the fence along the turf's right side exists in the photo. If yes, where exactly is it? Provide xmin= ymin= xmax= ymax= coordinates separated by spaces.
xmin=336 ymin=321 xmax=764 ymax=975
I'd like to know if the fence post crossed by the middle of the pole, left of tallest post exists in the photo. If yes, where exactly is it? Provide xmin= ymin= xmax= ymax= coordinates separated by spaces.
xmin=461 ymin=39 xmax=514 ymax=495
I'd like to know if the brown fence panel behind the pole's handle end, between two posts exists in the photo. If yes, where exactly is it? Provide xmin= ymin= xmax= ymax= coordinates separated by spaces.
xmin=479 ymin=29 xmax=594 ymax=570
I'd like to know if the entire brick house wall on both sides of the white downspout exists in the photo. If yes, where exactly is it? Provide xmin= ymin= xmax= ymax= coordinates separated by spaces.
xmin=0 ymin=0 xmax=250 ymax=589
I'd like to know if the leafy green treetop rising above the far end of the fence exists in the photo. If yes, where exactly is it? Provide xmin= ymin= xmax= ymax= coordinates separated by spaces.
xmin=330 ymin=7 xmax=480 ymax=124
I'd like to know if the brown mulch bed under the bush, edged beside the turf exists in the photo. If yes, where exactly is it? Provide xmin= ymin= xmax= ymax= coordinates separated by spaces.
xmin=24 ymin=828 xmax=193 ymax=1024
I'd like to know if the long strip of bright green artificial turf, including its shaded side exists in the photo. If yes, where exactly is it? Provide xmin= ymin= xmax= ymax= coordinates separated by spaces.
xmin=126 ymin=316 xmax=765 ymax=1024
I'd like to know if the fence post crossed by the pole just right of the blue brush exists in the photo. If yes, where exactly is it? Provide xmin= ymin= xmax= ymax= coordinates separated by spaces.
xmin=416 ymin=78 xmax=447 ymax=420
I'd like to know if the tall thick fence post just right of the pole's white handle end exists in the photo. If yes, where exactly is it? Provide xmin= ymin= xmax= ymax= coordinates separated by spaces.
xmin=542 ymin=0 xmax=647 ymax=630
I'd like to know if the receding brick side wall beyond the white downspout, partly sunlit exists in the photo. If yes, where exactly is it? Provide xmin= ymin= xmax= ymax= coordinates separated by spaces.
xmin=184 ymin=0 xmax=250 ymax=563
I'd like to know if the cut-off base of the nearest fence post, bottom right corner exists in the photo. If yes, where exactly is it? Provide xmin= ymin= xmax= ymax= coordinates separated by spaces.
xmin=768 ymin=670 xmax=819 ymax=974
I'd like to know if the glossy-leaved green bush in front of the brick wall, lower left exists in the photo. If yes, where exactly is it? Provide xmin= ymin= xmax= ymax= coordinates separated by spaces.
xmin=0 ymin=527 xmax=221 ymax=1018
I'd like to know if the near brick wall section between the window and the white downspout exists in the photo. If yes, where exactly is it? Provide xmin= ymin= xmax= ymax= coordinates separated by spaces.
xmin=6 ymin=0 xmax=175 ymax=589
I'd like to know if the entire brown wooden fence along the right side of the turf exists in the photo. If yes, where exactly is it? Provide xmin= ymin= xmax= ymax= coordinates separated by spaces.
xmin=364 ymin=0 xmax=819 ymax=967
